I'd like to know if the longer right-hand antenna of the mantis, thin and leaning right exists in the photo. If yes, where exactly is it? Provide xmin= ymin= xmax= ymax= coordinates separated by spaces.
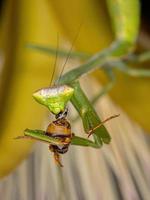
xmin=57 ymin=23 xmax=82 ymax=84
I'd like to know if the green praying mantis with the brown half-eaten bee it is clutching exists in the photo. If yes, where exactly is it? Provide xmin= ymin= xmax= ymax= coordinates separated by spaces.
xmin=18 ymin=0 xmax=150 ymax=166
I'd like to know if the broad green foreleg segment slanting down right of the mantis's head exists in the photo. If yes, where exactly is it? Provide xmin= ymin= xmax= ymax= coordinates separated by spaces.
xmin=71 ymin=82 xmax=115 ymax=146
